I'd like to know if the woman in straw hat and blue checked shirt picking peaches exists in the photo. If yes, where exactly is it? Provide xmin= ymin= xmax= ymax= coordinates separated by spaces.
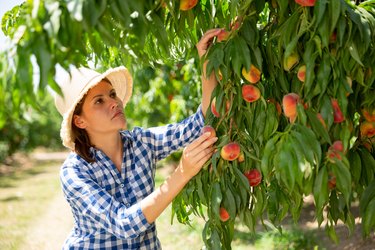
xmin=56 ymin=29 xmax=220 ymax=249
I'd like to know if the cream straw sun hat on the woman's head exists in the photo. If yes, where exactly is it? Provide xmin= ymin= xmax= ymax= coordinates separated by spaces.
xmin=55 ymin=66 xmax=133 ymax=150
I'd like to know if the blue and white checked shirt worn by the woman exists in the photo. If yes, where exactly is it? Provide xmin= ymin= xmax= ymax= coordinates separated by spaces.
xmin=60 ymin=108 xmax=204 ymax=250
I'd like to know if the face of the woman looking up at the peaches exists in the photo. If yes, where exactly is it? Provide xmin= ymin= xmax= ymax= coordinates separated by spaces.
xmin=73 ymin=81 xmax=126 ymax=137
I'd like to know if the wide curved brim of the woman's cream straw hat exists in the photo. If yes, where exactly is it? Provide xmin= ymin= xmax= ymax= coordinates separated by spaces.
xmin=60 ymin=66 xmax=133 ymax=151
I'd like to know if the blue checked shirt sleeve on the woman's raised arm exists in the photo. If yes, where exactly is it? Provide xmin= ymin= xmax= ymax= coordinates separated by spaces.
xmin=136 ymin=106 xmax=204 ymax=160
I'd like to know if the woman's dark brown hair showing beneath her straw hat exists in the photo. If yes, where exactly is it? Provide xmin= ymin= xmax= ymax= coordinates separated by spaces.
xmin=72 ymin=78 xmax=111 ymax=162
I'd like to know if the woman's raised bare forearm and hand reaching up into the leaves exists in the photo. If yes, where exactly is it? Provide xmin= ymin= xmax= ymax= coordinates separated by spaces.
xmin=196 ymin=29 xmax=221 ymax=117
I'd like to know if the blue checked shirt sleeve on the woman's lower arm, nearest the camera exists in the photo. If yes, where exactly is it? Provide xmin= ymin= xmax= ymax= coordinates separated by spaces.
xmin=60 ymin=167 xmax=150 ymax=239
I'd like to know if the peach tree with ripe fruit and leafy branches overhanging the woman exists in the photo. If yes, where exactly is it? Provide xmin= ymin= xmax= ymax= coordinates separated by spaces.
xmin=0 ymin=0 xmax=375 ymax=249
